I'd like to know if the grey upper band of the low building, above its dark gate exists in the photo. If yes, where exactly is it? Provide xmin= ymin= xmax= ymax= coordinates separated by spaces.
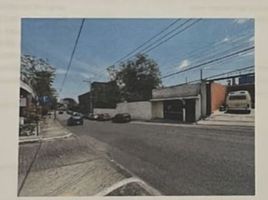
xmin=152 ymin=83 xmax=200 ymax=99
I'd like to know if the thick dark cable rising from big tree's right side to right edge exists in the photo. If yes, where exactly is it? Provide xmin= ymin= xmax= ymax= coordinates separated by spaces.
xmin=161 ymin=46 xmax=254 ymax=79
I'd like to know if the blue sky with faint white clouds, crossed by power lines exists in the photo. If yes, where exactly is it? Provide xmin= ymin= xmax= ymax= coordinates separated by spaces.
xmin=21 ymin=18 xmax=254 ymax=100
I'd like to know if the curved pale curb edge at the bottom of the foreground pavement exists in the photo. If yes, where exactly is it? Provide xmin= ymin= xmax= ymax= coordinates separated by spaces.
xmin=95 ymin=177 xmax=161 ymax=196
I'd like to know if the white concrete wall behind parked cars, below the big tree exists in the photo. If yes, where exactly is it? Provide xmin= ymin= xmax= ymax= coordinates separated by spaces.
xmin=116 ymin=101 xmax=152 ymax=120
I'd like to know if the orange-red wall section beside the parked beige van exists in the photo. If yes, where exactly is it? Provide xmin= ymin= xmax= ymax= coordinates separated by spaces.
xmin=210 ymin=83 xmax=226 ymax=112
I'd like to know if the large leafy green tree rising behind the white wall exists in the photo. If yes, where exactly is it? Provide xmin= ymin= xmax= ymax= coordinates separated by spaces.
xmin=107 ymin=54 xmax=161 ymax=101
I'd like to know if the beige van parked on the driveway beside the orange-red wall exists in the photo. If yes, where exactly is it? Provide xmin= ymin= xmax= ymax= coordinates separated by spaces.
xmin=226 ymin=90 xmax=251 ymax=113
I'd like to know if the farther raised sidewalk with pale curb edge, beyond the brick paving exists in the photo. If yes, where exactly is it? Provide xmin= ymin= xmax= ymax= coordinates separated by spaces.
xmin=19 ymin=117 xmax=72 ymax=143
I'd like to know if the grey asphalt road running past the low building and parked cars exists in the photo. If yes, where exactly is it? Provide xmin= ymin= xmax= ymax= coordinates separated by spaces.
xmin=59 ymin=116 xmax=255 ymax=195
